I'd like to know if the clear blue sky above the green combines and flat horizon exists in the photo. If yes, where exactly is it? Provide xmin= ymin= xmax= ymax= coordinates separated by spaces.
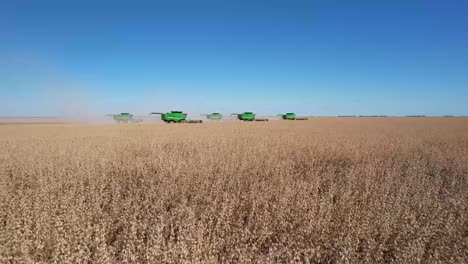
xmin=0 ymin=0 xmax=468 ymax=116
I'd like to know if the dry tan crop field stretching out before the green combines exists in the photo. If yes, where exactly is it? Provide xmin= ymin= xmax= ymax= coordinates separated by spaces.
xmin=0 ymin=118 xmax=468 ymax=263
